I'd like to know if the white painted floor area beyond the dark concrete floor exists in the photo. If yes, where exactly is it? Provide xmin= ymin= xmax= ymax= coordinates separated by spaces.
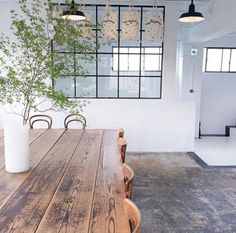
xmin=194 ymin=137 xmax=236 ymax=166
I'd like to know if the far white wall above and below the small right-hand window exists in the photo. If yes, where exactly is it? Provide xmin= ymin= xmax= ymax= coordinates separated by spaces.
xmin=201 ymin=35 xmax=236 ymax=134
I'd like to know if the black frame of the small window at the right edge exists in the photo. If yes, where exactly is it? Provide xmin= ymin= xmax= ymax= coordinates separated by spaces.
xmin=203 ymin=47 xmax=236 ymax=73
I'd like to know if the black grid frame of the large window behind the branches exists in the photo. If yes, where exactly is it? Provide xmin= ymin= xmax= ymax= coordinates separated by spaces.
xmin=52 ymin=3 xmax=165 ymax=99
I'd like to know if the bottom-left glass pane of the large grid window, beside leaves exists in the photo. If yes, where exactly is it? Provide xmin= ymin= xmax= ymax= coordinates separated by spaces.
xmin=54 ymin=77 xmax=74 ymax=97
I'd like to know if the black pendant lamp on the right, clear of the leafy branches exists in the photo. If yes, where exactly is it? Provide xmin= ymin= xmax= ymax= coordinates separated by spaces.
xmin=179 ymin=0 xmax=204 ymax=23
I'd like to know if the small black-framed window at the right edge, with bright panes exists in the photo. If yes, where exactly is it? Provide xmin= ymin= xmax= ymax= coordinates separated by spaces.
xmin=204 ymin=47 xmax=236 ymax=73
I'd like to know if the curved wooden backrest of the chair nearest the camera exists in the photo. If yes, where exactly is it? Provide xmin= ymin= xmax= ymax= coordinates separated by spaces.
xmin=125 ymin=198 xmax=141 ymax=233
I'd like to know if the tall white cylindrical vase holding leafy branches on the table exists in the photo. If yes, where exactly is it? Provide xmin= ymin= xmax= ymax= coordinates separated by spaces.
xmin=4 ymin=120 xmax=30 ymax=173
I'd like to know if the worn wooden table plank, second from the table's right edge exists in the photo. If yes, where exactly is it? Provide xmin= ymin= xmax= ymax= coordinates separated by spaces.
xmin=37 ymin=130 xmax=104 ymax=233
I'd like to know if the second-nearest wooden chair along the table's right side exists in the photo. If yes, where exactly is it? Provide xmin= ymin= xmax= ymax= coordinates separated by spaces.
xmin=122 ymin=163 xmax=134 ymax=199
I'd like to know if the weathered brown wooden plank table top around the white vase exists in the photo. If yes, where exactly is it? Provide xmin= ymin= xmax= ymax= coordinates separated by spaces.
xmin=0 ymin=129 xmax=130 ymax=233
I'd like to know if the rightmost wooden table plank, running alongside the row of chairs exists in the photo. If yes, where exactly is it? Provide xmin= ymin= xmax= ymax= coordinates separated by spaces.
xmin=89 ymin=130 xmax=130 ymax=233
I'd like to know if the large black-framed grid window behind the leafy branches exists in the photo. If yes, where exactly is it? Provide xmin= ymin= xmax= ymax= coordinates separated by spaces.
xmin=53 ymin=5 xmax=165 ymax=99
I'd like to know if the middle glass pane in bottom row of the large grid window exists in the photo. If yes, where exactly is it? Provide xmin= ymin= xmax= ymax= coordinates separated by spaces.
xmin=98 ymin=77 xmax=117 ymax=97
